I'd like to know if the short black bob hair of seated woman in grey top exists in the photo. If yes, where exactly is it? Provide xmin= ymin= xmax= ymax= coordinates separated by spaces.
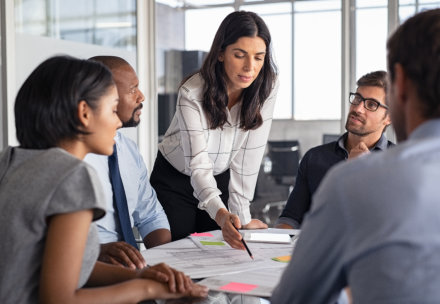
xmin=14 ymin=56 xmax=114 ymax=149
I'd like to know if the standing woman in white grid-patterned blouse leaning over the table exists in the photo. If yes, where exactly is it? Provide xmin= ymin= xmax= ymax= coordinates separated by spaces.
xmin=151 ymin=11 xmax=277 ymax=249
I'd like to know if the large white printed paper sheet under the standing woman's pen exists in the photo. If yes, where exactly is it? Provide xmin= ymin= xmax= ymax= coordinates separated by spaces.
xmin=141 ymin=229 xmax=295 ymax=283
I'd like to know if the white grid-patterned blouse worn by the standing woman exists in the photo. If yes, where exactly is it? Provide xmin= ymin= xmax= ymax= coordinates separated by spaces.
xmin=159 ymin=74 xmax=278 ymax=225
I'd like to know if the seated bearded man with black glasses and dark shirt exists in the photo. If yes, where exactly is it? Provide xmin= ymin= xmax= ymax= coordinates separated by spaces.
xmin=275 ymin=71 xmax=394 ymax=229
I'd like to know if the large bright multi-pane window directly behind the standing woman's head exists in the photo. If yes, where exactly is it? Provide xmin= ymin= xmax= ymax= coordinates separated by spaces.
xmin=185 ymin=0 xmax=341 ymax=119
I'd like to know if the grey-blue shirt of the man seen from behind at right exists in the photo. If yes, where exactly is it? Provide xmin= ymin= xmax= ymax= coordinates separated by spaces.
xmin=271 ymin=119 xmax=440 ymax=304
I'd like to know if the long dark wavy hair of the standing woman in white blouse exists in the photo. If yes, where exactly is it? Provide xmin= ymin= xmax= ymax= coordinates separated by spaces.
xmin=200 ymin=11 xmax=276 ymax=131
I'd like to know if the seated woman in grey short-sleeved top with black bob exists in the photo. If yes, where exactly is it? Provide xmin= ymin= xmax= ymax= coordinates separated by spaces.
xmin=0 ymin=56 xmax=206 ymax=304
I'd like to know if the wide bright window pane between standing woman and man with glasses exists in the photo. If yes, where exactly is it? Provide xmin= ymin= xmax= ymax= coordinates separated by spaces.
xmin=293 ymin=1 xmax=341 ymax=120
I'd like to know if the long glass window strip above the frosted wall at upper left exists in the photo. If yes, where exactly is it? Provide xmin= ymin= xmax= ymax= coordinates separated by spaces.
xmin=15 ymin=0 xmax=136 ymax=50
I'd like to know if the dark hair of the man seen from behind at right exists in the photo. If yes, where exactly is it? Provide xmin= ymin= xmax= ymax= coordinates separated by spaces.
xmin=387 ymin=9 xmax=440 ymax=118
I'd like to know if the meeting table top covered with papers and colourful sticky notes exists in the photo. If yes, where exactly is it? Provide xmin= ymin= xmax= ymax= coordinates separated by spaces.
xmin=141 ymin=228 xmax=300 ymax=304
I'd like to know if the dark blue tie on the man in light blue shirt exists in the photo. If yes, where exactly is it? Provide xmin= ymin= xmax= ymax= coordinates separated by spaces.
xmin=108 ymin=145 xmax=138 ymax=248
